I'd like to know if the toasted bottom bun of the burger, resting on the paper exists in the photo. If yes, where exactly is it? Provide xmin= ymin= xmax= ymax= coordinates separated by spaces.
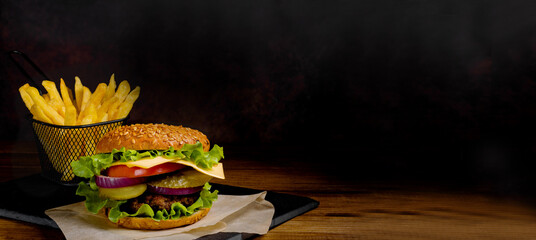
xmin=107 ymin=208 xmax=210 ymax=230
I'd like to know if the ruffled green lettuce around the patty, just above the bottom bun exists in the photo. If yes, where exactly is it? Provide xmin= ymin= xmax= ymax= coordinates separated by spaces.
xmin=76 ymin=182 xmax=218 ymax=223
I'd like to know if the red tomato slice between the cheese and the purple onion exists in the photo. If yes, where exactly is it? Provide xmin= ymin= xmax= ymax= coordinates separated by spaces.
xmin=108 ymin=163 xmax=185 ymax=178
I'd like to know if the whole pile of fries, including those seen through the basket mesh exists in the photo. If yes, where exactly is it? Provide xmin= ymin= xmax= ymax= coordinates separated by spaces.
xmin=19 ymin=74 xmax=140 ymax=181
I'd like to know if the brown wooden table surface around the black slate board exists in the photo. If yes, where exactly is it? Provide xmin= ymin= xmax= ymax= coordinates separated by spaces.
xmin=0 ymin=143 xmax=536 ymax=239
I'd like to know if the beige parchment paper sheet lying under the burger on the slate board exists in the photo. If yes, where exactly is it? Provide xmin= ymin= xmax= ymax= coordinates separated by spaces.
xmin=45 ymin=192 xmax=275 ymax=240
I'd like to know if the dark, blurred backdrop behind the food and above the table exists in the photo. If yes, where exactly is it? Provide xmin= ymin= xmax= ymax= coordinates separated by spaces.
xmin=0 ymin=0 xmax=536 ymax=194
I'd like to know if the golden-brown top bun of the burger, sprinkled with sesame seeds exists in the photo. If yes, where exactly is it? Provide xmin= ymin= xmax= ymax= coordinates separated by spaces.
xmin=95 ymin=124 xmax=210 ymax=153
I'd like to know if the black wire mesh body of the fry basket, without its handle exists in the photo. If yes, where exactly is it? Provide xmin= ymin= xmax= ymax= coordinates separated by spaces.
xmin=32 ymin=118 xmax=127 ymax=185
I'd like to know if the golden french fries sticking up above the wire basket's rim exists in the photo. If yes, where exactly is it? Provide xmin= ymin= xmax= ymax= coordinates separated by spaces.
xmin=19 ymin=74 xmax=140 ymax=126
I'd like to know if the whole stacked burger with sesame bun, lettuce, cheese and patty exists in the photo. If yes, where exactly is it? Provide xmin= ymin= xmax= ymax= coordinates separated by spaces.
xmin=71 ymin=124 xmax=225 ymax=229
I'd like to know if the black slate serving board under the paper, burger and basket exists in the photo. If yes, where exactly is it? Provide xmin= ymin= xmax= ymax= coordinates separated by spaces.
xmin=0 ymin=174 xmax=318 ymax=240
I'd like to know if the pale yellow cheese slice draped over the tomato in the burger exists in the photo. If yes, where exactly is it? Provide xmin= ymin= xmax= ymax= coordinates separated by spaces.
xmin=112 ymin=156 xmax=225 ymax=179
